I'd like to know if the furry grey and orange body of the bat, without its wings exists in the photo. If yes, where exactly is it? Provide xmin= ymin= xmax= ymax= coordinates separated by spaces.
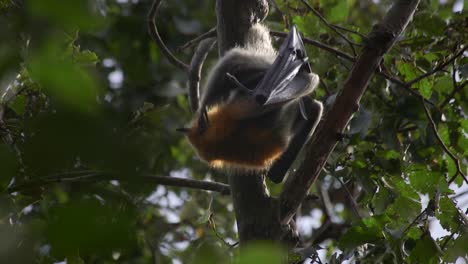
xmin=183 ymin=24 xmax=321 ymax=180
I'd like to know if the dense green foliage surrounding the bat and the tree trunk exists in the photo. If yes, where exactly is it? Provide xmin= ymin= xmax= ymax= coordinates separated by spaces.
xmin=0 ymin=0 xmax=468 ymax=263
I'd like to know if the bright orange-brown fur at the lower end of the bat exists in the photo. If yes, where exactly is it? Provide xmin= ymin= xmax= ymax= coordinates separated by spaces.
xmin=186 ymin=101 xmax=289 ymax=170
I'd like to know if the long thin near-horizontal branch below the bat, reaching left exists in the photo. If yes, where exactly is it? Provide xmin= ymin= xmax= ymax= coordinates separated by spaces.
xmin=7 ymin=171 xmax=230 ymax=195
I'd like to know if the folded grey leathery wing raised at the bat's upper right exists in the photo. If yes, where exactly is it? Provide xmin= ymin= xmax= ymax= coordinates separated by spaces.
xmin=253 ymin=27 xmax=312 ymax=105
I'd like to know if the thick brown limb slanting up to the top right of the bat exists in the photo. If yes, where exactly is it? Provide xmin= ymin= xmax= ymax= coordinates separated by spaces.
xmin=280 ymin=0 xmax=419 ymax=224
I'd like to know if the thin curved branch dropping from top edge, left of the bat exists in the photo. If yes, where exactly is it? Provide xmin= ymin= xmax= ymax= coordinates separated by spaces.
xmin=148 ymin=0 xmax=189 ymax=71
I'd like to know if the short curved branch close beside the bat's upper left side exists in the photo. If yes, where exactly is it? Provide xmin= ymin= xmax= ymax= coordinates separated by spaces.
xmin=189 ymin=38 xmax=216 ymax=113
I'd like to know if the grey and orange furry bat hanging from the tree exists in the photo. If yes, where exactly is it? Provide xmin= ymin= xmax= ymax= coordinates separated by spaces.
xmin=179 ymin=24 xmax=322 ymax=182
